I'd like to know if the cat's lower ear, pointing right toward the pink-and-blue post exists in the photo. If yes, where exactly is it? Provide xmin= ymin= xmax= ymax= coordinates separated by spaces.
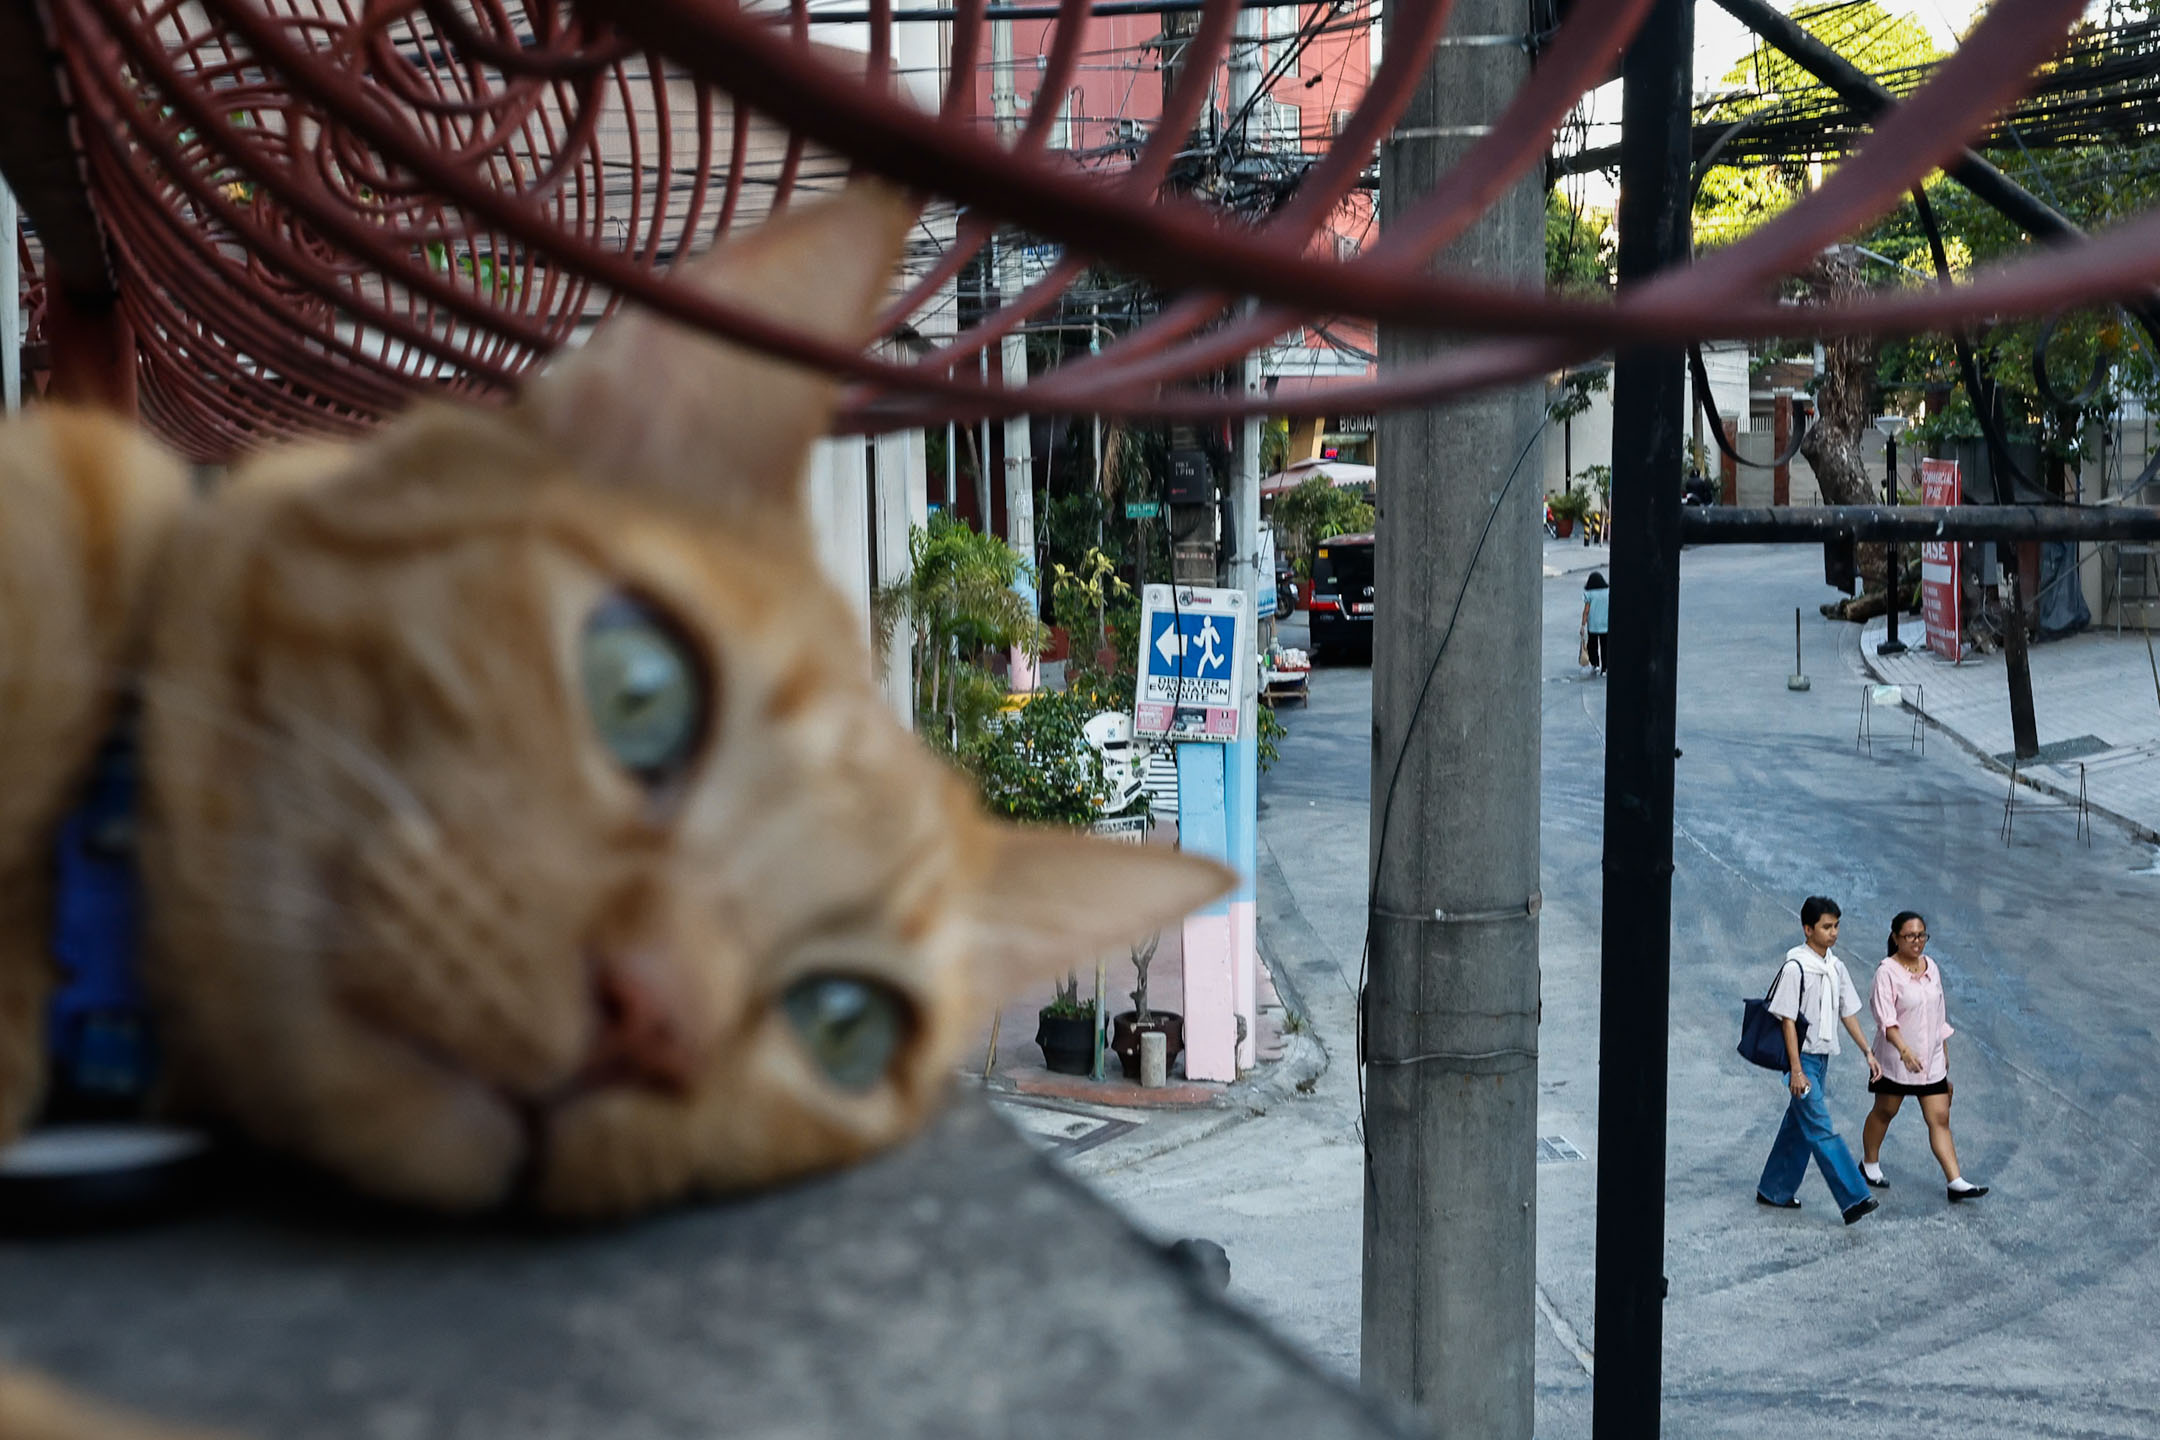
xmin=974 ymin=825 xmax=1238 ymax=997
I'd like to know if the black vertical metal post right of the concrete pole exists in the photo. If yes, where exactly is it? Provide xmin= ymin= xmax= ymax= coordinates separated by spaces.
xmin=1590 ymin=0 xmax=1696 ymax=1440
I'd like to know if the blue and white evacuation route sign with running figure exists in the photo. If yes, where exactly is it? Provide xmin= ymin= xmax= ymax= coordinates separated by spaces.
xmin=1132 ymin=585 xmax=1253 ymax=745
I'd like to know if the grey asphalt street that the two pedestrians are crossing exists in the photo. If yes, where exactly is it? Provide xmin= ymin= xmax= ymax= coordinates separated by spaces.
xmin=1082 ymin=548 xmax=2160 ymax=1440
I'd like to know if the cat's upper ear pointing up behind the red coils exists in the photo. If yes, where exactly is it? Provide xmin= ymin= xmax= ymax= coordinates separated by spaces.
xmin=521 ymin=181 xmax=916 ymax=514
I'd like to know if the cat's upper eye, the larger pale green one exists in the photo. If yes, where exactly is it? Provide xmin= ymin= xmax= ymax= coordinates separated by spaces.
xmin=579 ymin=596 xmax=708 ymax=784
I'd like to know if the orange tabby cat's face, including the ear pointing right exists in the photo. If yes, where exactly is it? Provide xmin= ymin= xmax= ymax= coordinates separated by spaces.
xmin=147 ymin=183 xmax=1229 ymax=1215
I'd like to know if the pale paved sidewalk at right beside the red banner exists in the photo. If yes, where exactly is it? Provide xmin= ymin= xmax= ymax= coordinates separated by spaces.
xmin=1851 ymin=615 xmax=2160 ymax=842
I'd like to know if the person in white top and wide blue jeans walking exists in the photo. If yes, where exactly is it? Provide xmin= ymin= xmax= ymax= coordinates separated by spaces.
xmin=1756 ymin=896 xmax=1881 ymax=1224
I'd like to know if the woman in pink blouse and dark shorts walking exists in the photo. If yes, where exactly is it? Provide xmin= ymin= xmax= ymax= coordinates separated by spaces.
xmin=1860 ymin=911 xmax=1987 ymax=1200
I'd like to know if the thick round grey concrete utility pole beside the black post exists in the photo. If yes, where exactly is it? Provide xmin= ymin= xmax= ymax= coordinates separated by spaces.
xmin=1363 ymin=0 xmax=1546 ymax=1440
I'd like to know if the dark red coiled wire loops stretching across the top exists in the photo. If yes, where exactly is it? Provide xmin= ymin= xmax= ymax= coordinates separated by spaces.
xmin=25 ymin=0 xmax=2160 ymax=460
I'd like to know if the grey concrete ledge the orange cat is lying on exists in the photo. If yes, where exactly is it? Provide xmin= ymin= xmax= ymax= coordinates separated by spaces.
xmin=0 ymin=1095 xmax=1410 ymax=1440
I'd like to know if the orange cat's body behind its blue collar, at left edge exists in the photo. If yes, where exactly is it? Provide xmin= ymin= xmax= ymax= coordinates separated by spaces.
xmin=0 ymin=406 xmax=188 ymax=1144
